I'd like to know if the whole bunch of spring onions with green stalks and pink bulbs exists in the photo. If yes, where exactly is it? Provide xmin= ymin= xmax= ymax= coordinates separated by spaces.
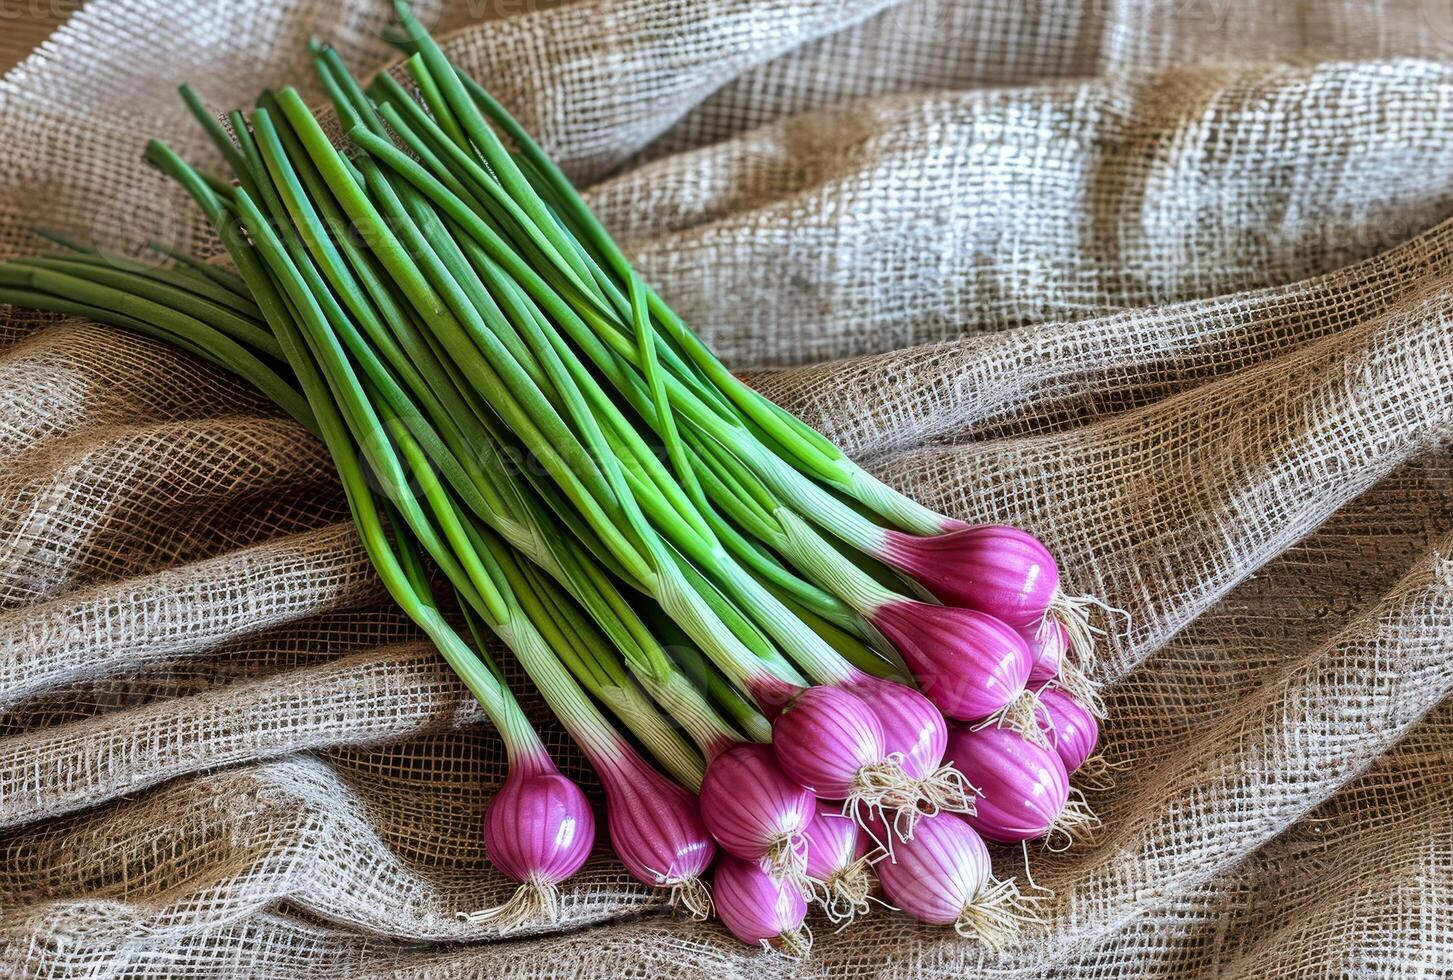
xmin=0 ymin=3 xmax=1121 ymax=951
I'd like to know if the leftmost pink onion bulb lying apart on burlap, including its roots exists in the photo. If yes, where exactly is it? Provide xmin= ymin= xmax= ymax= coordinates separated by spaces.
xmin=464 ymin=759 xmax=596 ymax=932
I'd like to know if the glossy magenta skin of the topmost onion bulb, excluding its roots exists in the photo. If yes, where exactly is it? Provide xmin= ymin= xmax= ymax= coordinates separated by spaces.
xmin=881 ymin=523 xmax=1059 ymax=630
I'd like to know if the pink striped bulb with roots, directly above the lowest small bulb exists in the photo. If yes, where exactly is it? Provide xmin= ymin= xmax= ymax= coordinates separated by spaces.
xmin=702 ymin=743 xmax=817 ymax=880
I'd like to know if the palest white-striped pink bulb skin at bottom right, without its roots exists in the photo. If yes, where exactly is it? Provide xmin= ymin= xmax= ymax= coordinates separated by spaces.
xmin=876 ymin=813 xmax=989 ymax=926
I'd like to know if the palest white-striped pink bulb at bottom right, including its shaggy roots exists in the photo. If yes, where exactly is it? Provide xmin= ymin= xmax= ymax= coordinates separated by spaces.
xmin=878 ymin=813 xmax=1030 ymax=949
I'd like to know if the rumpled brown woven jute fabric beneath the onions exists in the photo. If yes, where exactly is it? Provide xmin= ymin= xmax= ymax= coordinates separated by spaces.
xmin=0 ymin=0 xmax=1453 ymax=979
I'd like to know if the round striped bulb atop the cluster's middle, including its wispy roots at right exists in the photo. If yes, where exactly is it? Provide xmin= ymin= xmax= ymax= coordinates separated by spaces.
xmin=772 ymin=686 xmax=920 ymax=813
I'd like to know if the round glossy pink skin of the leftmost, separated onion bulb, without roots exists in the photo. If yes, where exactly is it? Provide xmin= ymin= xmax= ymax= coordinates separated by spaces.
xmin=484 ymin=771 xmax=596 ymax=884
